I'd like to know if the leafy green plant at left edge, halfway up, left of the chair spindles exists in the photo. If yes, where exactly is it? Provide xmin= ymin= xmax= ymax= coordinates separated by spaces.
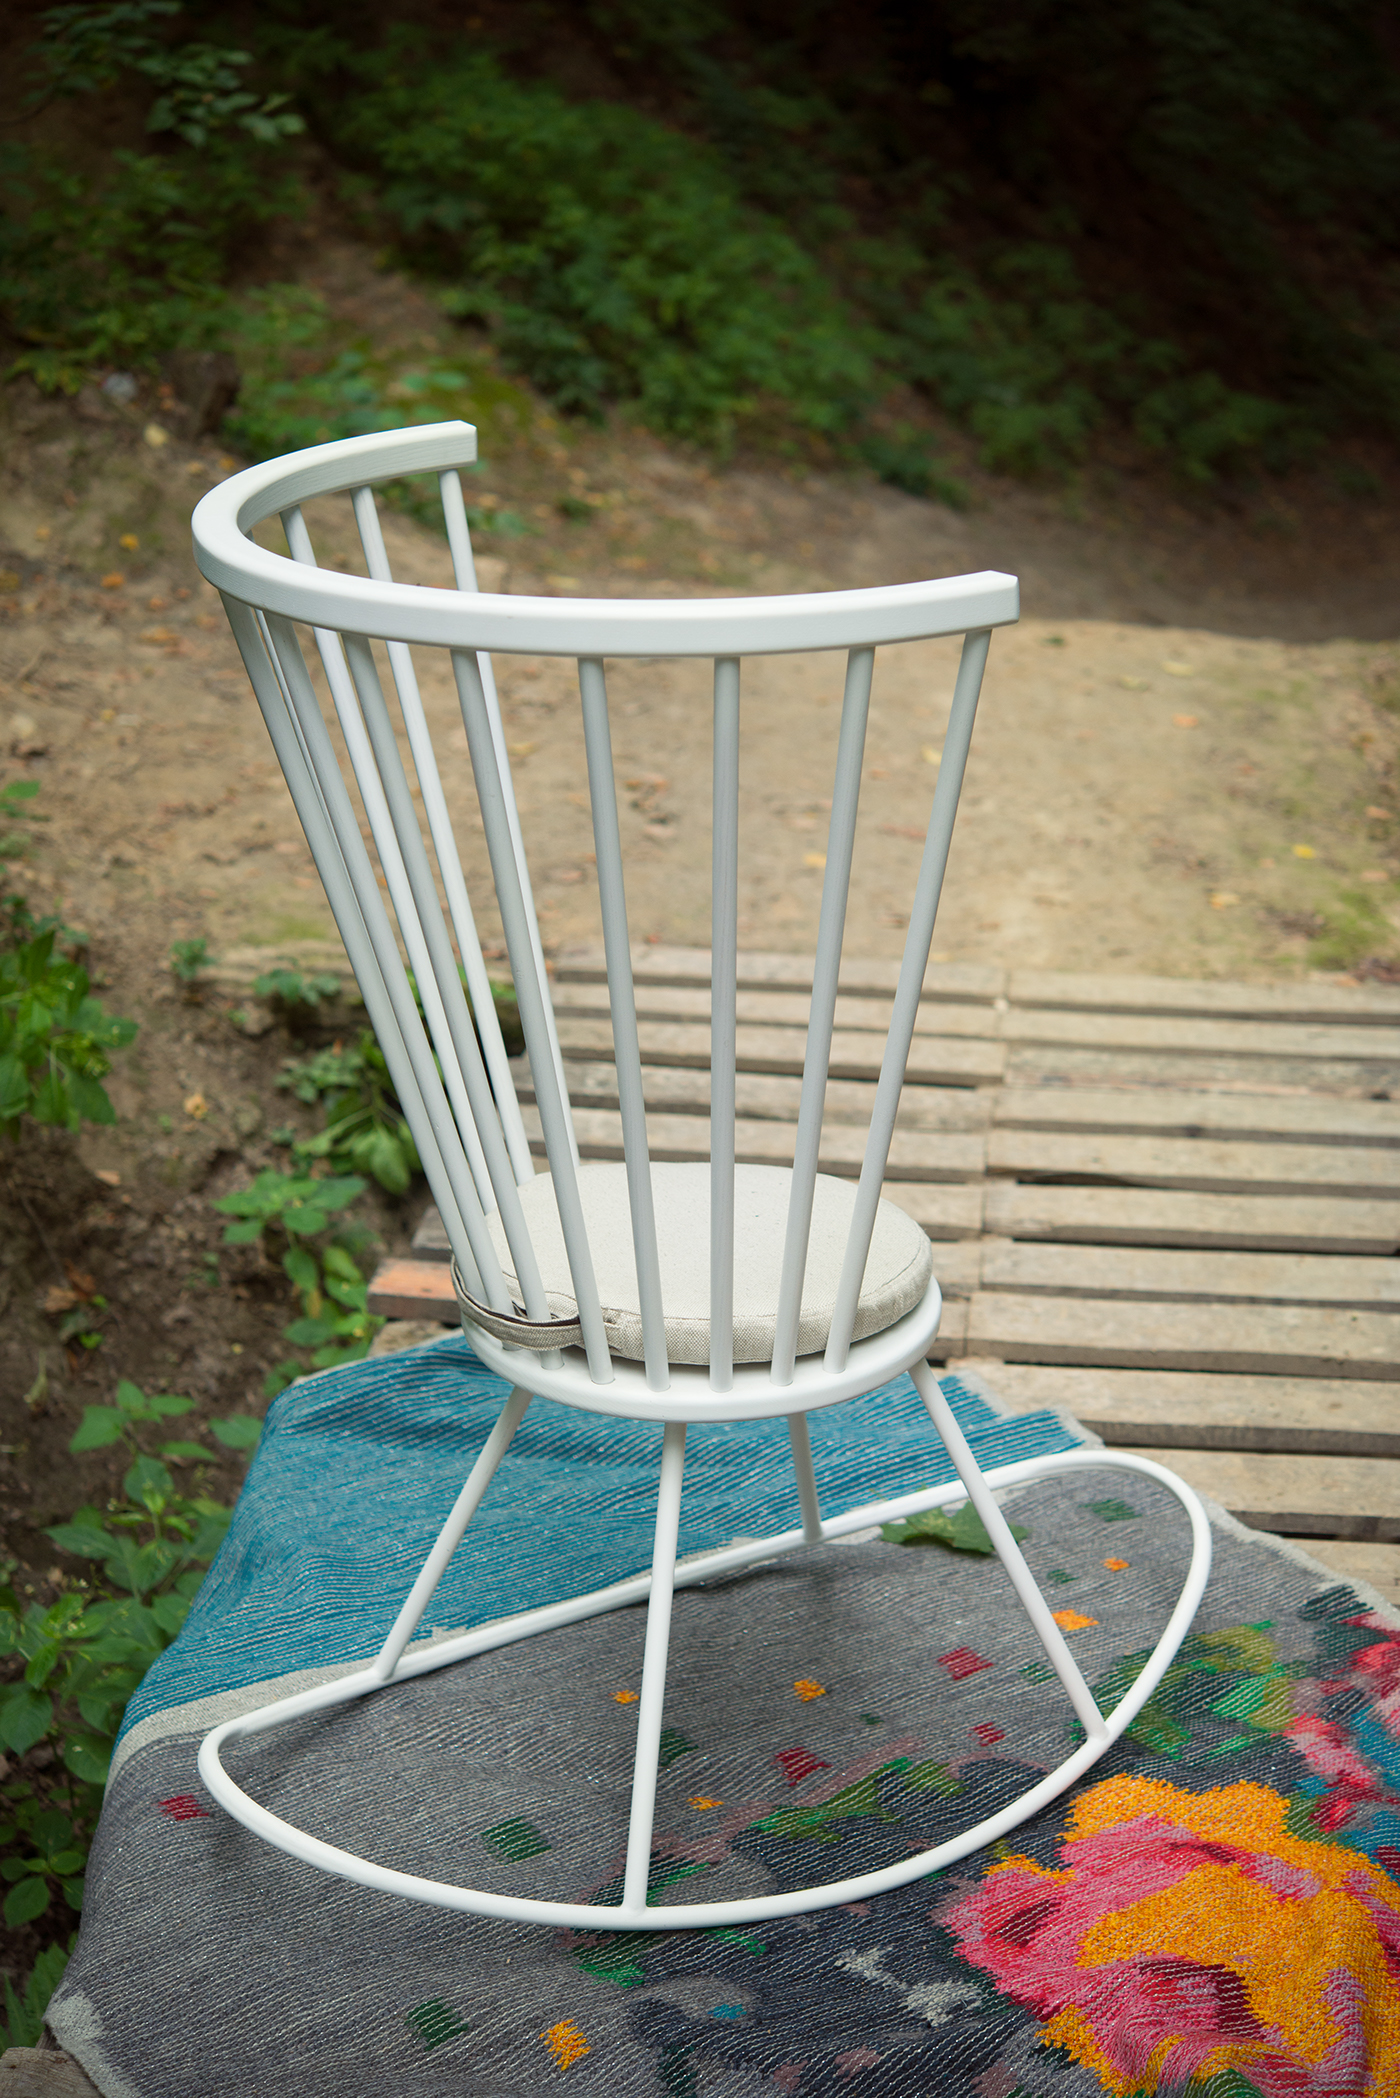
xmin=0 ymin=913 xmax=136 ymax=1137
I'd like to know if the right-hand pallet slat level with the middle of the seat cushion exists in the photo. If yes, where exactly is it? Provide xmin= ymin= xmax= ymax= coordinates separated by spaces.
xmin=973 ymin=1242 xmax=1400 ymax=1309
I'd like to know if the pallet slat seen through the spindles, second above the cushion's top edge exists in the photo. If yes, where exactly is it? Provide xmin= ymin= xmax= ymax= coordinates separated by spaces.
xmin=528 ymin=1057 xmax=993 ymax=1131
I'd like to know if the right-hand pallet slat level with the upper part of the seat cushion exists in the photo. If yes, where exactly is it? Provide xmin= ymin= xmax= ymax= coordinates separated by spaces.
xmin=987 ymin=1181 xmax=1400 ymax=1255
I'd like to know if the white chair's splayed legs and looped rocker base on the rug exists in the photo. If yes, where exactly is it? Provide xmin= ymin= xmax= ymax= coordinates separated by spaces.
xmin=199 ymin=1362 xmax=1211 ymax=1930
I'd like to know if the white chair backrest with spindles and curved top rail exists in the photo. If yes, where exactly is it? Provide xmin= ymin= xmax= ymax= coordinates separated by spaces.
xmin=193 ymin=422 xmax=1018 ymax=1391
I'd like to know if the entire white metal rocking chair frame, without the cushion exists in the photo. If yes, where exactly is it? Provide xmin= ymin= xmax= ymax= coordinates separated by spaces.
xmin=193 ymin=424 xmax=1211 ymax=1930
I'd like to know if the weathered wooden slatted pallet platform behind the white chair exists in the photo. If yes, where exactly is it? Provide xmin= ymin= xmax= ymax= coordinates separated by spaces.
xmin=372 ymin=946 xmax=1400 ymax=1599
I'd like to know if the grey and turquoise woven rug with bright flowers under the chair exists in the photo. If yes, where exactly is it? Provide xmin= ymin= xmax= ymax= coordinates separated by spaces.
xmin=50 ymin=1336 xmax=1400 ymax=2098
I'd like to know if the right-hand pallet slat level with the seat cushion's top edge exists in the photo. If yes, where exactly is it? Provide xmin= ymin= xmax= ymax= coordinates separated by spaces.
xmin=987 ymin=1129 xmax=1400 ymax=1200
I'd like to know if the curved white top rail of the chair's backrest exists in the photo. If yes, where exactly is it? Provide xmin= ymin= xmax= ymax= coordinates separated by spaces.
xmin=191 ymin=422 xmax=1020 ymax=657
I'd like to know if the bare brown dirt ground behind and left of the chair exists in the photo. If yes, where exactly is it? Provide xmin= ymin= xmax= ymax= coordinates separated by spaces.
xmin=0 ymin=250 xmax=1400 ymax=1586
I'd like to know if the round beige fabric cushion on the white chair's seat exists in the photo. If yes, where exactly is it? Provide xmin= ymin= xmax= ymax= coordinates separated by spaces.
xmin=465 ymin=1162 xmax=934 ymax=1364
